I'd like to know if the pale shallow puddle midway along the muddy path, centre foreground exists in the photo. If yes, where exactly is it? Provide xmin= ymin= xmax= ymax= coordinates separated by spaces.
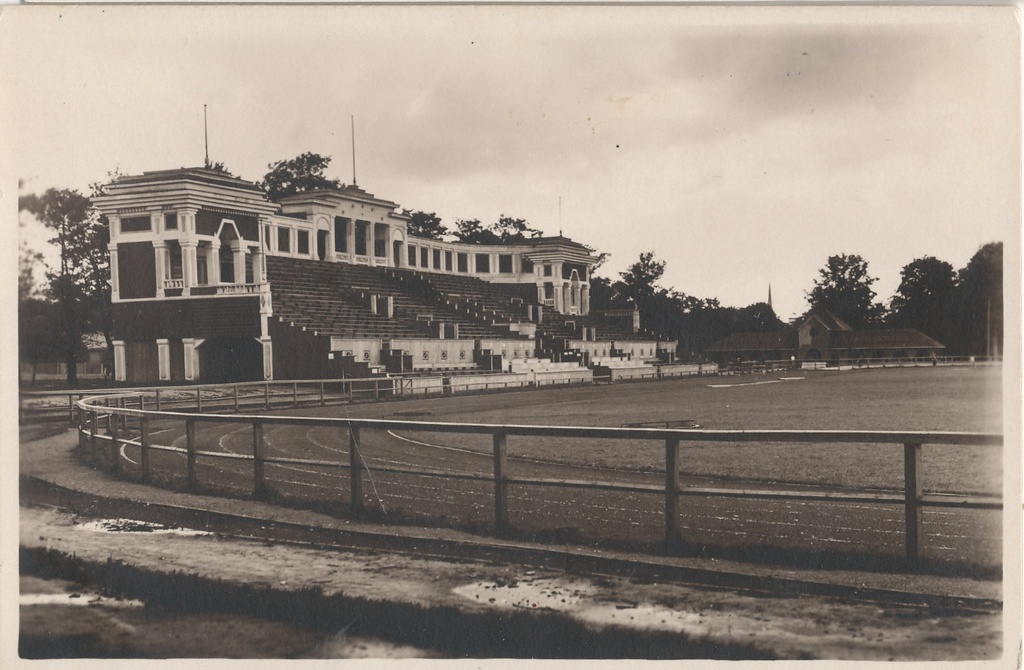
xmin=453 ymin=577 xmax=595 ymax=610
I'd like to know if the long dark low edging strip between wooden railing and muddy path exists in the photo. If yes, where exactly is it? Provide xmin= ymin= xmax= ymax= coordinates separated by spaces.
xmin=20 ymin=475 xmax=1002 ymax=614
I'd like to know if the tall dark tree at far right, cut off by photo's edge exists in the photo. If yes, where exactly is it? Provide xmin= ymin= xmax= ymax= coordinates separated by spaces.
xmin=954 ymin=242 xmax=1002 ymax=355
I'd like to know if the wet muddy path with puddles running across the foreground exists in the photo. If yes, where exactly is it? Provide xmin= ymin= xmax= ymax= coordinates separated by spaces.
xmin=20 ymin=507 xmax=1001 ymax=660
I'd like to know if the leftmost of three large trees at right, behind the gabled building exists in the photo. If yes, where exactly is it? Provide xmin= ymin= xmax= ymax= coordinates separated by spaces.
xmin=807 ymin=254 xmax=885 ymax=328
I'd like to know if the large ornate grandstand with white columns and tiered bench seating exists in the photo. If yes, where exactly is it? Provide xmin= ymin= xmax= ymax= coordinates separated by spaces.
xmin=94 ymin=168 xmax=676 ymax=383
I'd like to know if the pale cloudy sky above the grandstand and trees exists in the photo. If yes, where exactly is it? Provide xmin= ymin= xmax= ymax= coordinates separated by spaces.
xmin=0 ymin=5 xmax=1021 ymax=319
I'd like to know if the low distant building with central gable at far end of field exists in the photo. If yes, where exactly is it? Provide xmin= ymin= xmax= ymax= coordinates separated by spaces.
xmin=706 ymin=309 xmax=945 ymax=365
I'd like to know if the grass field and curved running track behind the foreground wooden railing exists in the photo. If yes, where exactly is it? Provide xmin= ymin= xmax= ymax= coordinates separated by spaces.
xmin=101 ymin=367 xmax=1001 ymax=570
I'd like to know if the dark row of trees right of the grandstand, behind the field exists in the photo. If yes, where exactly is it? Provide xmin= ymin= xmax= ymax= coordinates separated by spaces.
xmin=591 ymin=242 xmax=1002 ymax=358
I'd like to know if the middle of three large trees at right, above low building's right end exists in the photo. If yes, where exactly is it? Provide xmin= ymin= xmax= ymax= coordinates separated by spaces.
xmin=889 ymin=256 xmax=956 ymax=345
